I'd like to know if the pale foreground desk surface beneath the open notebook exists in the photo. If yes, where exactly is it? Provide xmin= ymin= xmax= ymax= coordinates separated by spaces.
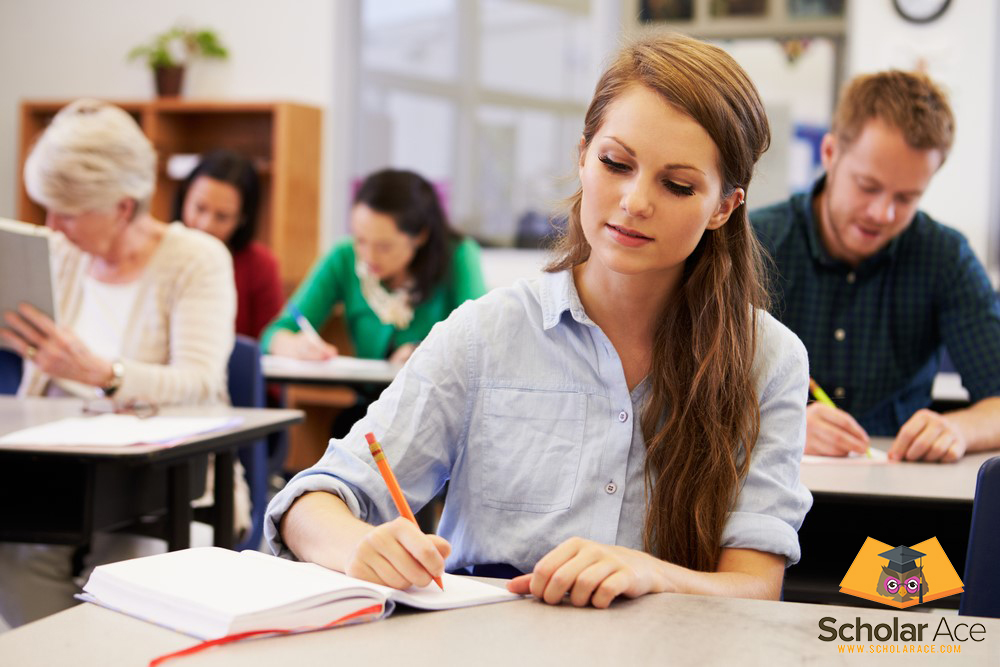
xmin=0 ymin=580 xmax=1000 ymax=667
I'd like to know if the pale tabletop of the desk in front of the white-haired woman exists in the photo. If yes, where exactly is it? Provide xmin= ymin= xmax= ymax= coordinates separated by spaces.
xmin=0 ymin=396 xmax=303 ymax=457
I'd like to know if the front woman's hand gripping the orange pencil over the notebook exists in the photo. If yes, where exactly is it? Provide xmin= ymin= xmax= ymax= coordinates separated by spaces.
xmin=344 ymin=517 xmax=451 ymax=589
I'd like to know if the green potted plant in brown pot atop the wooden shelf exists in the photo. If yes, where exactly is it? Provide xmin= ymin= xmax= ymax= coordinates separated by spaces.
xmin=128 ymin=26 xmax=229 ymax=97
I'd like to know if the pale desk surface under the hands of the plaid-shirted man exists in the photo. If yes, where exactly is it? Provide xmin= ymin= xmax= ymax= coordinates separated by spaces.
xmin=802 ymin=438 xmax=1000 ymax=503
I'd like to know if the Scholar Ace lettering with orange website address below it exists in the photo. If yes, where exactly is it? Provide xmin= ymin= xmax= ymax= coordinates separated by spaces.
xmin=818 ymin=616 xmax=986 ymax=654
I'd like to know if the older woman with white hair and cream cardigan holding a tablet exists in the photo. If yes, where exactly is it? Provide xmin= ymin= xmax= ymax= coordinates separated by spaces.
xmin=0 ymin=99 xmax=245 ymax=625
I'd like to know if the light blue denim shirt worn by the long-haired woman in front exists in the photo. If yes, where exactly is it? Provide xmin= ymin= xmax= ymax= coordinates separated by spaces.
xmin=264 ymin=271 xmax=812 ymax=572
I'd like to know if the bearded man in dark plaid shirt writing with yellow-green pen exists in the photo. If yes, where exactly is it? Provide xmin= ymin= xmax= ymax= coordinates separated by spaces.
xmin=751 ymin=71 xmax=1000 ymax=461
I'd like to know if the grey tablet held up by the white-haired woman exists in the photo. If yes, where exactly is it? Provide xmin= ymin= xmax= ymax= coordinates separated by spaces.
xmin=0 ymin=218 xmax=56 ymax=354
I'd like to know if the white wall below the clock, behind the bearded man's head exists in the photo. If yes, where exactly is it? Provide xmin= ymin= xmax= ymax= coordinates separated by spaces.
xmin=847 ymin=1 xmax=1000 ymax=269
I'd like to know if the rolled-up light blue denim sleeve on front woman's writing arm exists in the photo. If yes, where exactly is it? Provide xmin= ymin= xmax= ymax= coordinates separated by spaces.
xmin=264 ymin=308 xmax=471 ymax=557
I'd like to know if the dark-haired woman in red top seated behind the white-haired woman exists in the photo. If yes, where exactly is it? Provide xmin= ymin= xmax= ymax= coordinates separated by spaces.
xmin=174 ymin=150 xmax=285 ymax=338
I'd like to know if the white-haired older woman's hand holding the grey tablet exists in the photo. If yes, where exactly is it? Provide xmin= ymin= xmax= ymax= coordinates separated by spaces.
xmin=0 ymin=303 xmax=112 ymax=387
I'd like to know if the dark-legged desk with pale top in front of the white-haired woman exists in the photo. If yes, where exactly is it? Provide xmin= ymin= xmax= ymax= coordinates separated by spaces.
xmin=0 ymin=396 xmax=302 ymax=549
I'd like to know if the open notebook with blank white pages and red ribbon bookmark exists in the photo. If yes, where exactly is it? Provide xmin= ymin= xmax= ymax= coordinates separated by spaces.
xmin=80 ymin=547 xmax=521 ymax=639
